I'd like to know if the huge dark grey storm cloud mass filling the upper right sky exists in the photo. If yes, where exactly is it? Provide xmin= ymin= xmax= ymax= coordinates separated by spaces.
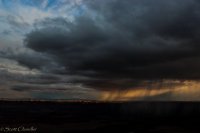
xmin=25 ymin=0 xmax=200 ymax=89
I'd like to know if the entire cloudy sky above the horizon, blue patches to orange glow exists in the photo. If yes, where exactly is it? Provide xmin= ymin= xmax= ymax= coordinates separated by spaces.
xmin=0 ymin=0 xmax=200 ymax=101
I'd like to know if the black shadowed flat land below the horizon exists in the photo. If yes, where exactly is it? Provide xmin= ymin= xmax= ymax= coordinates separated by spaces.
xmin=0 ymin=101 xmax=200 ymax=133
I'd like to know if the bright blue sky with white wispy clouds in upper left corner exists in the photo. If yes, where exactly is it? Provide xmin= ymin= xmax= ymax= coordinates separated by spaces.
xmin=0 ymin=0 xmax=85 ymax=34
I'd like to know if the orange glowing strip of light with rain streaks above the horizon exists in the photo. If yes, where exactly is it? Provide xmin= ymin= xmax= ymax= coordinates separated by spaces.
xmin=100 ymin=80 xmax=200 ymax=101
